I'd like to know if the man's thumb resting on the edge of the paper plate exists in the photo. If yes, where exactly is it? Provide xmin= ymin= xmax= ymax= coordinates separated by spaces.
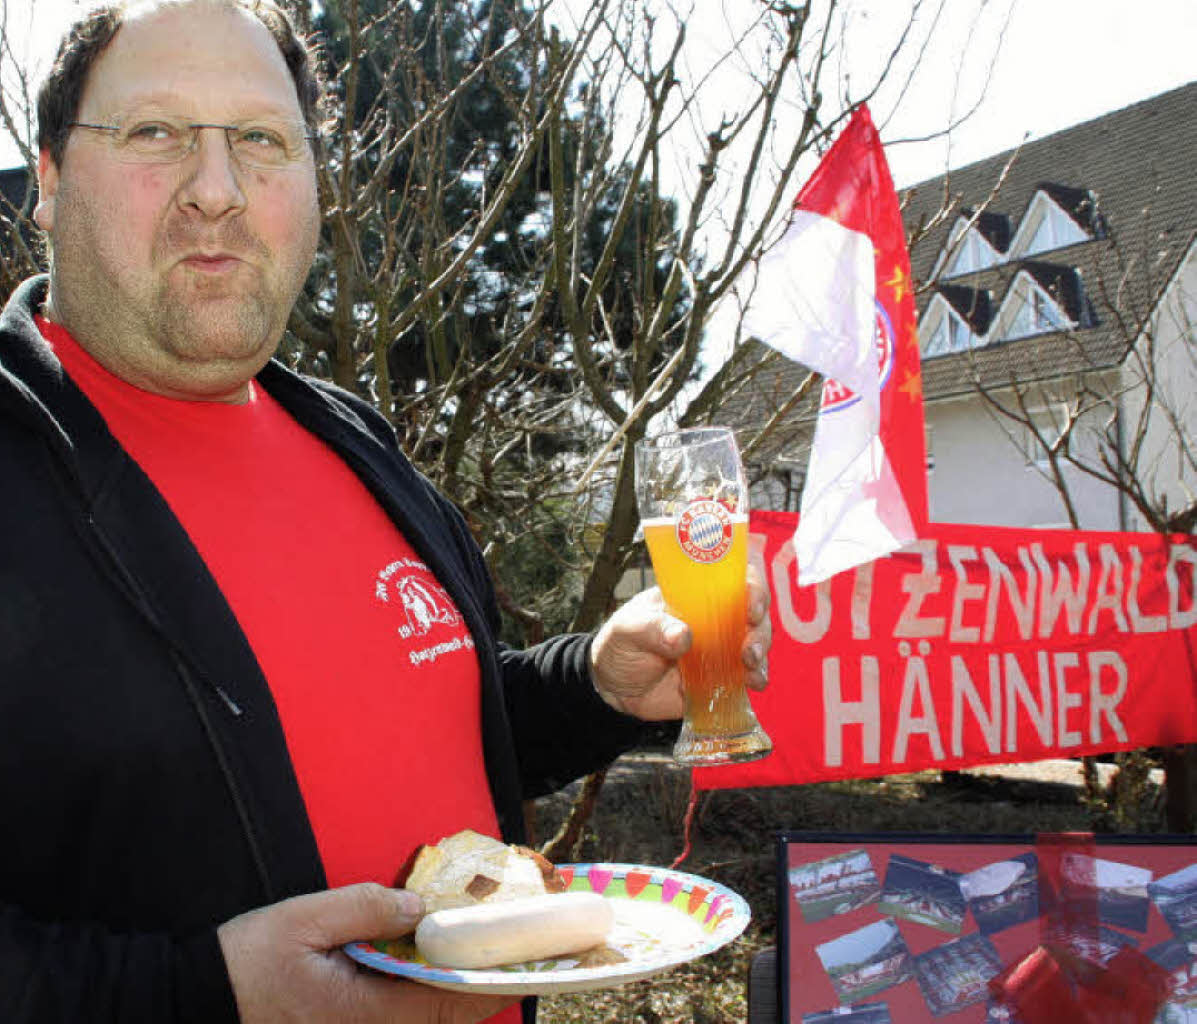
xmin=290 ymin=881 xmax=424 ymax=950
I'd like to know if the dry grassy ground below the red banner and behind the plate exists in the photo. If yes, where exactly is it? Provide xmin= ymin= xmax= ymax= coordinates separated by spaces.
xmin=536 ymin=755 xmax=1160 ymax=1024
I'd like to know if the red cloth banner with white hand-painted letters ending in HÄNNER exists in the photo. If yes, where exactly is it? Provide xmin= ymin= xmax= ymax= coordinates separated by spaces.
xmin=694 ymin=511 xmax=1197 ymax=789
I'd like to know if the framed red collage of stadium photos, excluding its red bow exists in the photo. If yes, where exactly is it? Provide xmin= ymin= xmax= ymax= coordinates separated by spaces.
xmin=777 ymin=831 xmax=1197 ymax=1024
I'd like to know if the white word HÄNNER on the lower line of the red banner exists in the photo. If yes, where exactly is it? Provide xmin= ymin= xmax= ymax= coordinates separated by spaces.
xmin=822 ymin=640 xmax=1130 ymax=768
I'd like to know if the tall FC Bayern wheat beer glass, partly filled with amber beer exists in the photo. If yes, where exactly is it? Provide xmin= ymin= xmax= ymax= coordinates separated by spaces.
xmin=636 ymin=426 xmax=773 ymax=764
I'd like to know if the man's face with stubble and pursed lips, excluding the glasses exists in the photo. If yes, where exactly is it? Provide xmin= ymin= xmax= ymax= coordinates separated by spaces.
xmin=36 ymin=0 xmax=320 ymax=401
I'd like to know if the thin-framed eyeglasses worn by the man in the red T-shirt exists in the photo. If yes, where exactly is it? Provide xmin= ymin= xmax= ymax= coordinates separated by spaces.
xmin=68 ymin=116 xmax=315 ymax=170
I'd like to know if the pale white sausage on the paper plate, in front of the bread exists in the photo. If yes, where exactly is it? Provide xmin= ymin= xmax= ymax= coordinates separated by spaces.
xmin=415 ymin=892 xmax=615 ymax=970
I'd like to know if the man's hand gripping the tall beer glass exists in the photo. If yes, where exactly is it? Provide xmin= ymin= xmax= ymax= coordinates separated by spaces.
xmin=590 ymin=545 xmax=773 ymax=721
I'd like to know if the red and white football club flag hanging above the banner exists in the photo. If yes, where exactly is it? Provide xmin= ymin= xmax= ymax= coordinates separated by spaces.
xmin=745 ymin=104 xmax=926 ymax=586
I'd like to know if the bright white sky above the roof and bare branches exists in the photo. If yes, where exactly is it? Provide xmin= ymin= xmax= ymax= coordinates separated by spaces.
xmin=0 ymin=0 xmax=1197 ymax=187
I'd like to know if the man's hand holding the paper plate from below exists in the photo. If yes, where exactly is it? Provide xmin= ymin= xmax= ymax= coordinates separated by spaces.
xmin=217 ymin=883 xmax=516 ymax=1024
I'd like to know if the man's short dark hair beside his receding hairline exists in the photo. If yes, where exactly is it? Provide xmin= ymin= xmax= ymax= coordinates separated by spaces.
xmin=37 ymin=0 xmax=321 ymax=164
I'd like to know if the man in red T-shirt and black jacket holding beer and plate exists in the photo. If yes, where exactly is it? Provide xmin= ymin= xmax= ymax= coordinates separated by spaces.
xmin=0 ymin=0 xmax=768 ymax=1022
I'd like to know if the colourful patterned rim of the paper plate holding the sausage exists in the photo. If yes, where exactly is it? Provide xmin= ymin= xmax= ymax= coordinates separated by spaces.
xmin=345 ymin=864 xmax=752 ymax=995
